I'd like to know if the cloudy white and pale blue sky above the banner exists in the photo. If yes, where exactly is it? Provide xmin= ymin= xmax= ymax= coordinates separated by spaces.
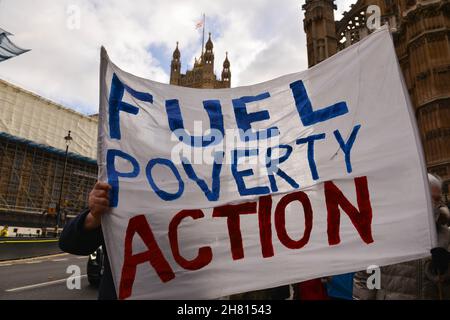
xmin=0 ymin=0 xmax=356 ymax=114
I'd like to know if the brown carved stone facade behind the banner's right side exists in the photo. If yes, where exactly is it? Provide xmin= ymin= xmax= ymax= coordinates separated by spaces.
xmin=303 ymin=0 xmax=450 ymax=201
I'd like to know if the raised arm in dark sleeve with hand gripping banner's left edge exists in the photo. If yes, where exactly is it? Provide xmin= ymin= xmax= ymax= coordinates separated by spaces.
xmin=59 ymin=182 xmax=111 ymax=255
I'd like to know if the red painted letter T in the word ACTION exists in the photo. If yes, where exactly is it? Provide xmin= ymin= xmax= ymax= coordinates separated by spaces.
xmin=213 ymin=202 xmax=256 ymax=260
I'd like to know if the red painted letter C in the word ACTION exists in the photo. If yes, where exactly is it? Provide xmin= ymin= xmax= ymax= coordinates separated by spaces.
xmin=169 ymin=210 xmax=212 ymax=270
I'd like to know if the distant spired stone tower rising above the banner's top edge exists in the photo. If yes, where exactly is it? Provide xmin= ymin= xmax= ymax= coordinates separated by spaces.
xmin=170 ymin=33 xmax=231 ymax=89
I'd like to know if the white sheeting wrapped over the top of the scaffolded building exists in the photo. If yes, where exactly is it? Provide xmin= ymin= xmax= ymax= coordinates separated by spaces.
xmin=0 ymin=80 xmax=97 ymax=159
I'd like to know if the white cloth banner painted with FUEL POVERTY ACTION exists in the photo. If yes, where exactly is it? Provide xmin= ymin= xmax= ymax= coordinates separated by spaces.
xmin=98 ymin=28 xmax=435 ymax=299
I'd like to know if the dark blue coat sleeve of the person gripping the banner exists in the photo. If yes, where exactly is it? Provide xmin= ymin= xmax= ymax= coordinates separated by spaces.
xmin=59 ymin=210 xmax=104 ymax=256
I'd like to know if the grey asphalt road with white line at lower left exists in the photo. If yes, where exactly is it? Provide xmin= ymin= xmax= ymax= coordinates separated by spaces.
xmin=0 ymin=253 xmax=98 ymax=300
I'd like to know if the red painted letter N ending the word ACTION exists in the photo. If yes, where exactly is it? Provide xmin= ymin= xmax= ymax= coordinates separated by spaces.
xmin=325 ymin=177 xmax=373 ymax=245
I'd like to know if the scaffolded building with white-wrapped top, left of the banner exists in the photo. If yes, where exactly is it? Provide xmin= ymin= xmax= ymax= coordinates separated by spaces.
xmin=0 ymin=80 xmax=98 ymax=228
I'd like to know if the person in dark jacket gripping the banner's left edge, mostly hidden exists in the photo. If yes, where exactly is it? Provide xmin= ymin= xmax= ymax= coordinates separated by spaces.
xmin=59 ymin=182 xmax=117 ymax=300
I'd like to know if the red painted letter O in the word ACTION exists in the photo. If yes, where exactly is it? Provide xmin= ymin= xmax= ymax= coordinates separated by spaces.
xmin=275 ymin=191 xmax=313 ymax=249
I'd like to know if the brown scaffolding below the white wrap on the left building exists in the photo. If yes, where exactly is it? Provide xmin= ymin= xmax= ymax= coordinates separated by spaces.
xmin=0 ymin=133 xmax=97 ymax=218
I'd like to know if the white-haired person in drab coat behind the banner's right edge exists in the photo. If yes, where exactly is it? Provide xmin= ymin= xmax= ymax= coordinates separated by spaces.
xmin=353 ymin=174 xmax=450 ymax=300
